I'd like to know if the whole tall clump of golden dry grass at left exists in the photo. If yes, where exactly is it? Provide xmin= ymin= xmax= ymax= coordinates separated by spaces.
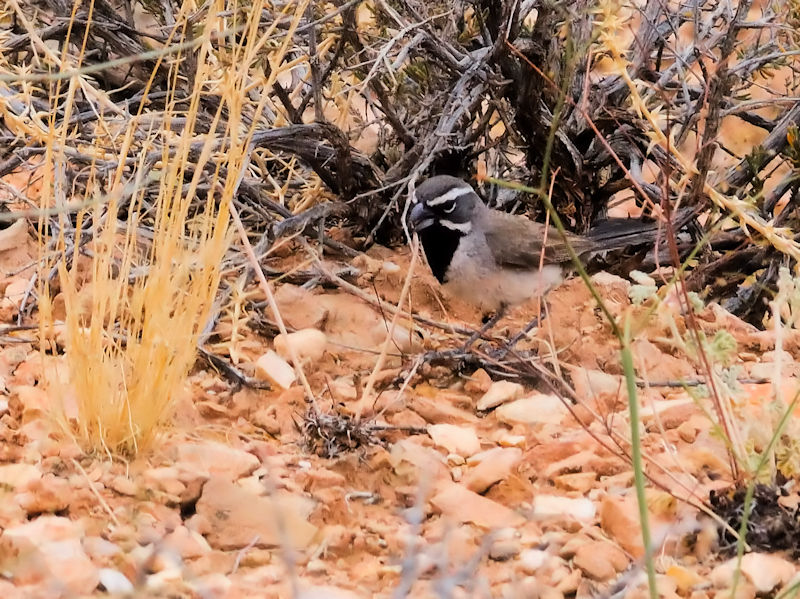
xmin=17 ymin=3 xmax=305 ymax=453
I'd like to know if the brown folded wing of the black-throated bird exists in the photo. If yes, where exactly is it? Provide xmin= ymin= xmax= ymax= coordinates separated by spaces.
xmin=484 ymin=210 xmax=594 ymax=268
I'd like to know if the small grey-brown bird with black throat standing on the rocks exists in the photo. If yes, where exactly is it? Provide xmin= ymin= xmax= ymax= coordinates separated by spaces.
xmin=410 ymin=175 xmax=680 ymax=314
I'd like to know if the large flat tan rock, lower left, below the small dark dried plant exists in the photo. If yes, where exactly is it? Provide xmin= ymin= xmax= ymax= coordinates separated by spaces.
xmin=189 ymin=476 xmax=317 ymax=551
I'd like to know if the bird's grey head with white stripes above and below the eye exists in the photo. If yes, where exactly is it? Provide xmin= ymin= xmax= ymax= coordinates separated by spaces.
xmin=410 ymin=175 xmax=483 ymax=235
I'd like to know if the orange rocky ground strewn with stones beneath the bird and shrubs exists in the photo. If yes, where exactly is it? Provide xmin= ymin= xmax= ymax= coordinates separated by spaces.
xmin=0 ymin=226 xmax=800 ymax=599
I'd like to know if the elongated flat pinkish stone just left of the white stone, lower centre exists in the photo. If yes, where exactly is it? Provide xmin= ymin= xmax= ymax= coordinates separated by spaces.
xmin=430 ymin=481 xmax=525 ymax=529
